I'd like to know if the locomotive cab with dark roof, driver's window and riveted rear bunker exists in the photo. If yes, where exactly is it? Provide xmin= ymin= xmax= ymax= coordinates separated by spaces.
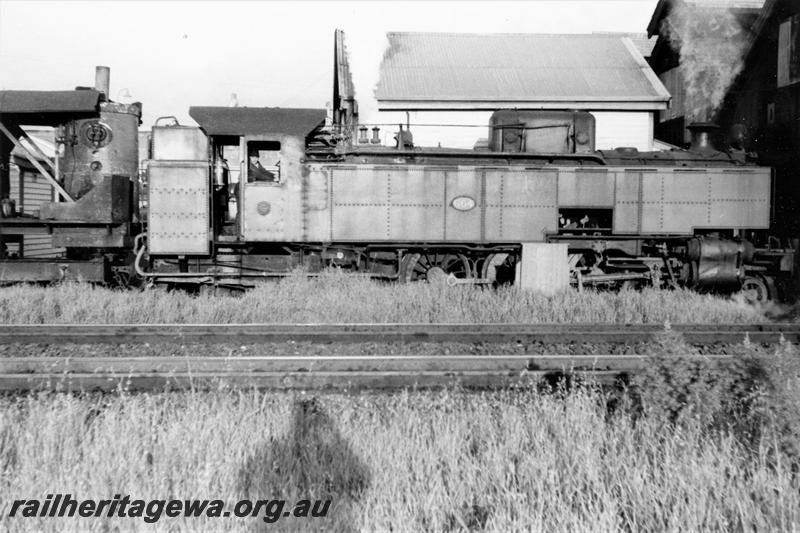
xmin=140 ymin=107 xmax=325 ymax=277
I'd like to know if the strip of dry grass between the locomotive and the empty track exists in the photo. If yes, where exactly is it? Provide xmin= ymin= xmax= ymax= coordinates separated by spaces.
xmin=0 ymin=272 xmax=767 ymax=324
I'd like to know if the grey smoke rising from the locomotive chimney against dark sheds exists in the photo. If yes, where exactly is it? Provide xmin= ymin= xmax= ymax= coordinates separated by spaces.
xmin=661 ymin=2 xmax=747 ymax=121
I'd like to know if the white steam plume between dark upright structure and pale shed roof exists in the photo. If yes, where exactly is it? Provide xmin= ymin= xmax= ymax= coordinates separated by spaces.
xmin=345 ymin=27 xmax=389 ymax=128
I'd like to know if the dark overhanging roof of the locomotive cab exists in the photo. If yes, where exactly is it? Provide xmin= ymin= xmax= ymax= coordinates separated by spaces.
xmin=189 ymin=107 xmax=325 ymax=137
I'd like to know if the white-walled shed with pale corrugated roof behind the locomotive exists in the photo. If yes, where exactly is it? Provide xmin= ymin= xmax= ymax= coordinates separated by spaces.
xmin=374 ymin=33 xmax=670 ymax=150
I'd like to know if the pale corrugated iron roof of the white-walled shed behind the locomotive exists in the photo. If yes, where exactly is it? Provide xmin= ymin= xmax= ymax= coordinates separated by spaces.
xmin=376 ymin=33 xmax=669 ymax=109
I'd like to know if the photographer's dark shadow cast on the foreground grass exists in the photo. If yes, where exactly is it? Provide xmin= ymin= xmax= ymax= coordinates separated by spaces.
xmin=238 ymin=398 xmax=369 ymax=532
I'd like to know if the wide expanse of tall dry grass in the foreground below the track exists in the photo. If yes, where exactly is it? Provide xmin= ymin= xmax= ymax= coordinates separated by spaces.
xmin=0 ymin=380 xmax=800 ymax=532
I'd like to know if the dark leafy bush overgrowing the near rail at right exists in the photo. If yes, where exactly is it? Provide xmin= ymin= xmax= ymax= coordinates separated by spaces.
xmin=632 ymin=330 xmax=800 ymax=469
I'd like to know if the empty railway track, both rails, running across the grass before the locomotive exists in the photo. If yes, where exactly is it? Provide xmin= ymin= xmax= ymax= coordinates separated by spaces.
xmin=0 ymin=324 xmax=800 ymax=392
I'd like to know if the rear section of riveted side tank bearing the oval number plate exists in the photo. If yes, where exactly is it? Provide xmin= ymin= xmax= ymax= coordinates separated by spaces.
xmin=304 ymin=164 xmax=557 ymax=244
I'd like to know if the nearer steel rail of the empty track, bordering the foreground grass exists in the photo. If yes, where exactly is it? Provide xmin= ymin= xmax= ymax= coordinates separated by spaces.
xmin=0 ymin=355 xmax=730 ymax=392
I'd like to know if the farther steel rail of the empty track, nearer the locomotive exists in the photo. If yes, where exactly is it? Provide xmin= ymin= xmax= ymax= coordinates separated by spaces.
xmin=0 ymin=323 xmax=800 ymax=344
